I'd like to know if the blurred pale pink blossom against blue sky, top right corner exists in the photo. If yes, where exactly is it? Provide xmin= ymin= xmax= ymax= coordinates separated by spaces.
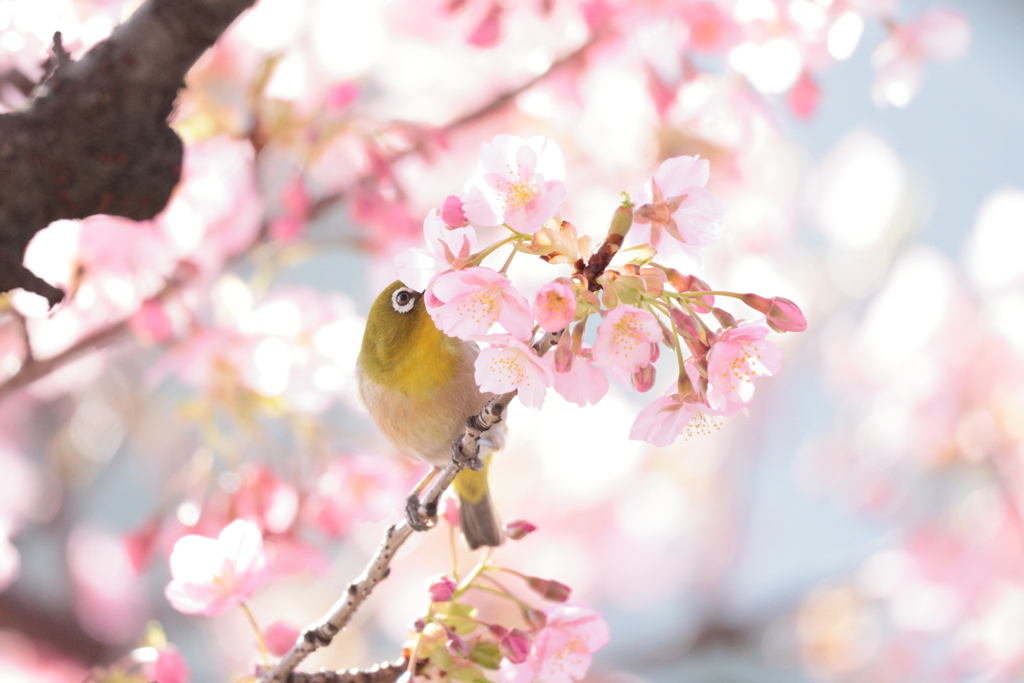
xmin=871 ymin=7 xmax=971 ymax=106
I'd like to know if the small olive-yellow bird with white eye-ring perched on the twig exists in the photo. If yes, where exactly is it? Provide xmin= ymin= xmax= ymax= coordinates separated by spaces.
xmin=356 ymin=282 xmax=504 ymax=550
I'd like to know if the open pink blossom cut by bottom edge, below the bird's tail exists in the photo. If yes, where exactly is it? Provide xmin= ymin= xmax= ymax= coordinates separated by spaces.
xmin=498 ymin=605 xmax=608 ymax=683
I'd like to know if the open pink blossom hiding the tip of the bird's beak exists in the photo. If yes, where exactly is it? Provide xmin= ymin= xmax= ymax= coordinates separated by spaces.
xmin=425 ymin=266 xmax=534 ymax=340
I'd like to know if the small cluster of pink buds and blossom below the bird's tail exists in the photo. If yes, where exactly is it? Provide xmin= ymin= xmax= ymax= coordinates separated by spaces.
xmin=404 ymin=516 xmax=608 ymax=683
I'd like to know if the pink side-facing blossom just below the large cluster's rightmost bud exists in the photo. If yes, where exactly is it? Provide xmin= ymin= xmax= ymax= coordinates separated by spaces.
xmin=707 ymin=324 xmax=782 ymax=415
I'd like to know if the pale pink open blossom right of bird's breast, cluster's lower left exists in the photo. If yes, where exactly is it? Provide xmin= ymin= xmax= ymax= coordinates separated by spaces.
xmin=475 ymin=335 xmax=553 ymax=408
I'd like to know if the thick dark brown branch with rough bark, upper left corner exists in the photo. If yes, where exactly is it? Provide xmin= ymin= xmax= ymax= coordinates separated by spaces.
xmin=0 ymin=0 xmax=255 ymax=305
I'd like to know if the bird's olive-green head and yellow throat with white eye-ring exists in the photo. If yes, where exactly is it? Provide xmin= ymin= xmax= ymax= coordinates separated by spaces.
xmin=358 ymin=282 xmax=460 ymax=396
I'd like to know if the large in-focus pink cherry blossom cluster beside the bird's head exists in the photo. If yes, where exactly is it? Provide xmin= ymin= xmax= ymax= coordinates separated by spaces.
xmin=395 ymin=135 xmax=806 ymax=445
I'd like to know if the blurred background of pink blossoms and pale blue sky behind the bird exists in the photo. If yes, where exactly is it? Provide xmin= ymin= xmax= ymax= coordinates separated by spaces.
xmin=0 ymin=0 xmax=1024 ymax=683
